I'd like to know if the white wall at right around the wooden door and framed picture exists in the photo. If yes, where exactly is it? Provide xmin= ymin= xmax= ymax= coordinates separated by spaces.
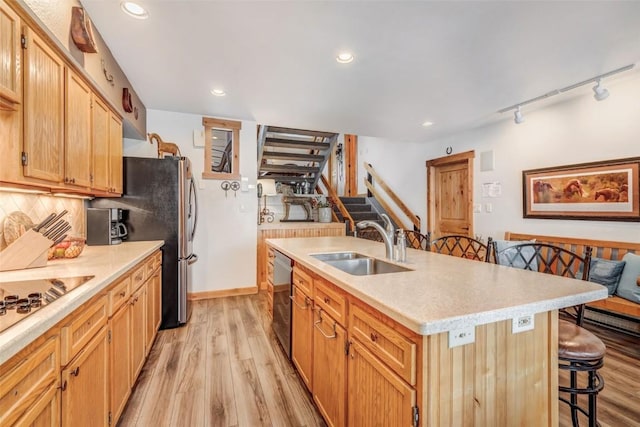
xmin=358 ymin=74 xmax=640 ymax=242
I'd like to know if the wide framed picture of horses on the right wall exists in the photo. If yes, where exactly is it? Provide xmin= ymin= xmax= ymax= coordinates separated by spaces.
xmin=522 ymin=157 xmax=640 ymax=221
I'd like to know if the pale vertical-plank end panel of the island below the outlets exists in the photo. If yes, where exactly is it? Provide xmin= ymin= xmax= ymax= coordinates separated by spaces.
xmin=421 ymin=311 xmax=558 ymax=426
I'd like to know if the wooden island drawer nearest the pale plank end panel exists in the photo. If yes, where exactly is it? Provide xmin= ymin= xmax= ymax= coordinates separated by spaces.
xmin=349 ymin=304 xmax=416 ymax=385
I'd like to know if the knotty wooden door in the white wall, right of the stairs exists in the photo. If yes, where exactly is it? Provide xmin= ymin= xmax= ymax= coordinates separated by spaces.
xmin=427 ymin=151 xmax=474 ymax=239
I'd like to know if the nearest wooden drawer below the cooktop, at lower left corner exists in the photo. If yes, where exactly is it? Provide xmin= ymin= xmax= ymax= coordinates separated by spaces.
xmin=0 ymin=335 xmax=60 ymax=426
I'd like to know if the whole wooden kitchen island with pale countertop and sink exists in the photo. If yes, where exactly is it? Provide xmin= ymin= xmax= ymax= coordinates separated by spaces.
xmin=267 ymin=237 xmax=607 ymax=426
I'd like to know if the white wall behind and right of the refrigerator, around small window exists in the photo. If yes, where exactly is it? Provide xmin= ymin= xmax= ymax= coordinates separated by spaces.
xmin=124 ymin=110 xmax=257 ymax=292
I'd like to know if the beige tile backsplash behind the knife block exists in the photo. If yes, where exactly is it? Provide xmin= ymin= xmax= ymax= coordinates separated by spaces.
xmin=0 ymin=191 xmax=87 ymax=250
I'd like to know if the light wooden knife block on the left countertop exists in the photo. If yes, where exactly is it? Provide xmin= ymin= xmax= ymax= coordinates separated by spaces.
xmin=0 ymin=230 xmax=53 ymax=271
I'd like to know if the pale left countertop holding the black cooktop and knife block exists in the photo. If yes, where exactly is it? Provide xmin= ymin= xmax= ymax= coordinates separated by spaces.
xmin=0 ymin=240 xmax=164 ymax=364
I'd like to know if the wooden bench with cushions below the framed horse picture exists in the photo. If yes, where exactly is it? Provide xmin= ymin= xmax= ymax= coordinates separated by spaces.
xmin=504 ymin=231 xmax=640 ymax=333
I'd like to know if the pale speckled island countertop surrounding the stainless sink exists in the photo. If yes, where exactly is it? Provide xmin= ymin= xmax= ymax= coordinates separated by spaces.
xmin=267 ymin=237 xmax=607 ymax=335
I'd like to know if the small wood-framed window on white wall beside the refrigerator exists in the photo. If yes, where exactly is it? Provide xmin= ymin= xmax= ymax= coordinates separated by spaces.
xmin=202 ymin=117 xmax=242 ymax=179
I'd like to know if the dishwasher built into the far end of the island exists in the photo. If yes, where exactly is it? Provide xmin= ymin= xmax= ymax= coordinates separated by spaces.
xmin=272 ymin=251 xmax=293 ymax=359
